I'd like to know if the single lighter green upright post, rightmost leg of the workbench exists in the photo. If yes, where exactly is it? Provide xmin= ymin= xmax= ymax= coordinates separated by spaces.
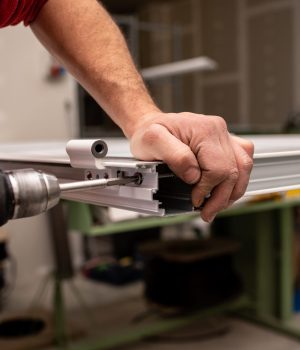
xmin=279 ymin=207 xmax=294 ymax=321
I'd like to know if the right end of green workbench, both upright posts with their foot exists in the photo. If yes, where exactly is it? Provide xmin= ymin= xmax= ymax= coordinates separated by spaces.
xmin=239 ymin=207 xmax=300 ymax=340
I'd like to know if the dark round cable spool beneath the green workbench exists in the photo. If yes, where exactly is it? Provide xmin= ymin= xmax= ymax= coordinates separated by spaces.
xmin=140 ymin=239 xmax=242 ymax=311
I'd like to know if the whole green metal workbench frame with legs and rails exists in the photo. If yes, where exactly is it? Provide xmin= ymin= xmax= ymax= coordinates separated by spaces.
xmin=54 ymin=198 xmax=300 ymax=350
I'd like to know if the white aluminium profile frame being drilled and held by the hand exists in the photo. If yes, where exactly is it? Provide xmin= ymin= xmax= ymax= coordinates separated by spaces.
xmin=0 ymin=135 xmax=300 ymax=215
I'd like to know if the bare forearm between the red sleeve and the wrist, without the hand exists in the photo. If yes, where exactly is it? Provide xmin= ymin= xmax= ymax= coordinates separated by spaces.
xmin=31 ymin=0 xmax=158 ymax=137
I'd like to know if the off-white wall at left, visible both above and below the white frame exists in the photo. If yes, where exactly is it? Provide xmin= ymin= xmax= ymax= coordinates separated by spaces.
xmin=0 ymin=25 xmax=81 ymax=293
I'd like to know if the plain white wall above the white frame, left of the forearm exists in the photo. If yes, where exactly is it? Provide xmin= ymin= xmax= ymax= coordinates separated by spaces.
xmin=0 ymin=26 xmax=77 ymax=142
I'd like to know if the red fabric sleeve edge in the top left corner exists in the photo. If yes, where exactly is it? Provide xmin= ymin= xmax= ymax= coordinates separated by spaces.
xmin=0 ymin=0 xmax=47 ymax=28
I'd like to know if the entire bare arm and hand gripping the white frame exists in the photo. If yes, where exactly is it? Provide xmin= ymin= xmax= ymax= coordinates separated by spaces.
xmin=31 ymin=0 xmax=253 ymax=221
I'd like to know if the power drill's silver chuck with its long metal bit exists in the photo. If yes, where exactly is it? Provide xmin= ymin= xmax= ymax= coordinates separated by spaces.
xmin=0 ymin=169 xmax=140 ymax=226
